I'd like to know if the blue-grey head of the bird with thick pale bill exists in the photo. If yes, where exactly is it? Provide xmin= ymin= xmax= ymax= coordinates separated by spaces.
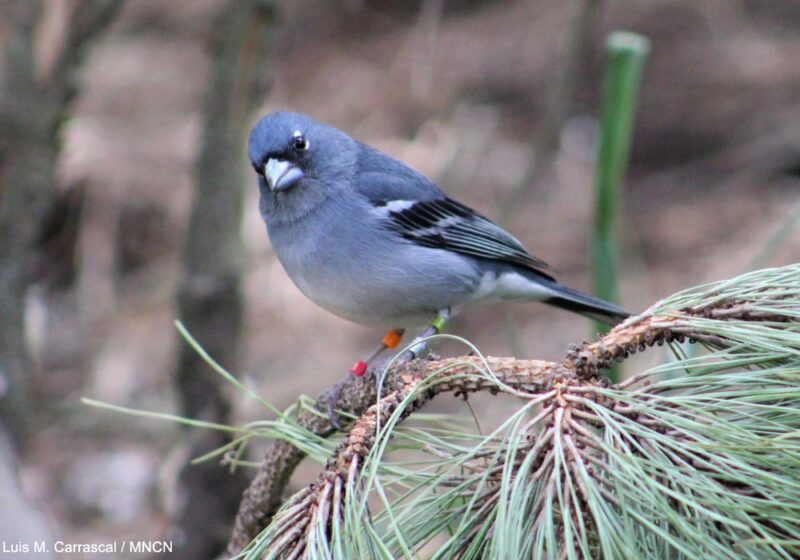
xmin=248 ymin=111 xmax=357 ymax=193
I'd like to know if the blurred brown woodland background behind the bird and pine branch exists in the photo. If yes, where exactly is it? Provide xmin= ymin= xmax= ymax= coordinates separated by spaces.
xmin=0 ymin=0 xmax=800 ymax=559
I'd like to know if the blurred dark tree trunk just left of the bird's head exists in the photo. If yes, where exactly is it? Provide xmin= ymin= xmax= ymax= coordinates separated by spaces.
xmin=175 ymin=0 xmax=272 ymax=560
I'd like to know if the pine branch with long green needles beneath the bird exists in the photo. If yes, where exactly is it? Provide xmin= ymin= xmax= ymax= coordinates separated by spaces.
xmin=228 ymin=266 xmax=800 ymax=558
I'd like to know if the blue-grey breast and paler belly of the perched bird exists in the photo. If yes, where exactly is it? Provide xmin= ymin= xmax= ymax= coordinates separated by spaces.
xmin=269 ymin=206 xmax=477 ymax=327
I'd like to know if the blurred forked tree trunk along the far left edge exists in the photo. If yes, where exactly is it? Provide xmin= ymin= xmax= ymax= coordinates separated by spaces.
xmin=0 ymin=0 xmax=122 ymax=443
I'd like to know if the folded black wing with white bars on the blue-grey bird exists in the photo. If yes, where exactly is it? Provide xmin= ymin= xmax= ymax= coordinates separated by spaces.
xmin=374 ymin=197 xmax=555 ymax=280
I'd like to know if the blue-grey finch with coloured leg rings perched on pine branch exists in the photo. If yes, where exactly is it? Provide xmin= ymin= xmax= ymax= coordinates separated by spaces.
xmin=247 ymin=111 xmax=630 ymax=424
